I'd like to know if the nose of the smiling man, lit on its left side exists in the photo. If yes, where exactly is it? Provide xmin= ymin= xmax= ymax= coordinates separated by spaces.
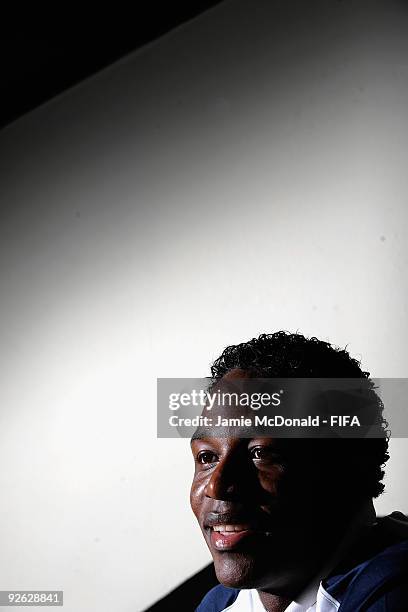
xmin=205 ymin=459 xmax=248 ymax=500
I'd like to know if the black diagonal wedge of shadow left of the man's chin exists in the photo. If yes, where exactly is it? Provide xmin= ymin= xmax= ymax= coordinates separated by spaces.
xmin=145 ymin=563 xmax=218 ymax=612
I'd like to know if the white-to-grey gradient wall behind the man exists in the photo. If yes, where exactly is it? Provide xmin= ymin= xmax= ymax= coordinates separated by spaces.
xmin=0 ymin=0 xmax=408 ymax=612
